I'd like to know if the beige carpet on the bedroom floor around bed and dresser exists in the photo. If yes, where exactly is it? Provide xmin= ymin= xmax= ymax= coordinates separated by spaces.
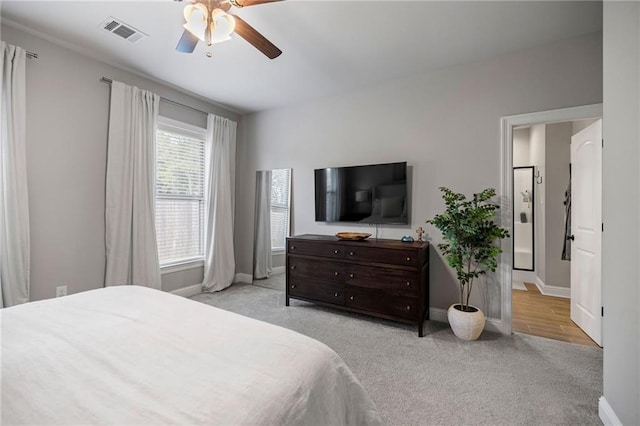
xmin=192 ymin=284 xmax=602 ymax=425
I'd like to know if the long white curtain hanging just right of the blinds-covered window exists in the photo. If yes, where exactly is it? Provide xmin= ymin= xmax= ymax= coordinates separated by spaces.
xmin=202 ymin=114 xmax=237 ymax=292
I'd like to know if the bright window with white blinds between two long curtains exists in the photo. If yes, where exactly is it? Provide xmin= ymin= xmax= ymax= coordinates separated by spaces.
xmin=156 ymin=118 xmax=205 ymax=266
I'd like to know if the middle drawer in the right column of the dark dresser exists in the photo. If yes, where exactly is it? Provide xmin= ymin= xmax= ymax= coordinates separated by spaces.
xmin=342 ymin=264 xmax=420 ymax=297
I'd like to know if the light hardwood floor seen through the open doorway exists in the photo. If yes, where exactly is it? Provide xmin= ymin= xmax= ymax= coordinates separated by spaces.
xmin=512 ymin=283 xmax=598 ymax=347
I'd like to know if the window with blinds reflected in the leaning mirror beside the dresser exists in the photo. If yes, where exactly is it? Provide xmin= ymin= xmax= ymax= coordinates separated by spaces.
xmin=271 ymin=169 xmax=291 ymax=251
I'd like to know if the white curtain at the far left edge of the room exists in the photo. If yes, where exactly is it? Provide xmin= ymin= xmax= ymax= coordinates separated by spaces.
xmin=0 ymin=42 xmax=30 ymax=308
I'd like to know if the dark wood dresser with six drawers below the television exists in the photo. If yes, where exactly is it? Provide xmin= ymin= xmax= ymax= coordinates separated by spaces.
xmin=286 ymin=235 xmax=429 ymax=337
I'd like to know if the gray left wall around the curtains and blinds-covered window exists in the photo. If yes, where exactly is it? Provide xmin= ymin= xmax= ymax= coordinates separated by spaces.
xmin=2 ymin=25 xmax=238 ymax=300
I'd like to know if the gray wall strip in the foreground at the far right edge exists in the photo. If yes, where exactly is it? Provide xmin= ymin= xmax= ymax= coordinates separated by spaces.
xmin=602 ymin=1 xmax=640 ymax=425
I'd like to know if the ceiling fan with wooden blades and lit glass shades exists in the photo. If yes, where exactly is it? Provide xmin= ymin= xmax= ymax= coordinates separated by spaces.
xmin=176 ymin=0 xmax=282 ymax=59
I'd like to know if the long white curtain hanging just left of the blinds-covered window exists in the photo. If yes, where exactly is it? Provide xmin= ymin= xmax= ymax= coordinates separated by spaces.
xmin=105 ymin=81 xmax=160 ymax=289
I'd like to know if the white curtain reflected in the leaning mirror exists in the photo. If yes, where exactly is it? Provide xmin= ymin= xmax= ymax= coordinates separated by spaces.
xmin=253 ymin=170 xmax=273 ymax=279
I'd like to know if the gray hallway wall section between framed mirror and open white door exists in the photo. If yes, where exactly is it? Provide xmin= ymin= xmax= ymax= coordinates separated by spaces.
xmin=538 ymin=122 xmax=572 ymax=288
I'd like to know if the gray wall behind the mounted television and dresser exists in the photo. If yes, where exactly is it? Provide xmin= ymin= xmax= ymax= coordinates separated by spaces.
xmin=236 ymin=33 xmax=602 ymax=317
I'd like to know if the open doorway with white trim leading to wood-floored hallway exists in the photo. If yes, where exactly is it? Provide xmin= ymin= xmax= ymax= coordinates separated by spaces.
xmin=501 ymin=105 xmax=602 ymax=344
